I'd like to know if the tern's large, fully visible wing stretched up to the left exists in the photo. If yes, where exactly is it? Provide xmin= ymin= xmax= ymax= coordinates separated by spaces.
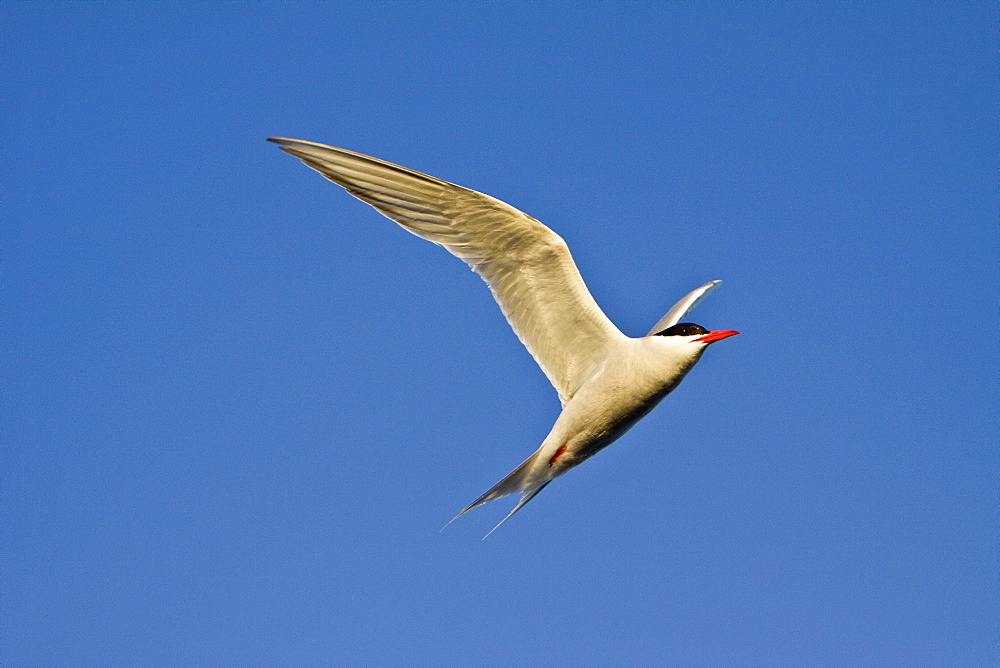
xmin=270 ymin=138 xmax=624 ymax=403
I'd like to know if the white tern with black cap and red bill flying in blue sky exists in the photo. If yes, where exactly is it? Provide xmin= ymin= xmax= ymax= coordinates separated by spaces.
xmin=269 ymin=137 xmax=739 ymax=536
